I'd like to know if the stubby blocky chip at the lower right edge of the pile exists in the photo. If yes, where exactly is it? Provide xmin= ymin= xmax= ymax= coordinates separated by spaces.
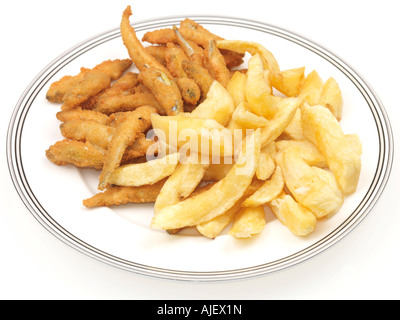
xmin=269 ymin=192 xmax=317 ymax=237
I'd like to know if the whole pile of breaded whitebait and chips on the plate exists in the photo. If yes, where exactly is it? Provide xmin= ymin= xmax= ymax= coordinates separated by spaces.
xmin=46 ymin=6 xmax=362 ymax=241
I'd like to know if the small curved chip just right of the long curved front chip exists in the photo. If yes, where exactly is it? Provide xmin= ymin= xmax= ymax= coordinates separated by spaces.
xmin=242 ymin=166 xmax=285 ymax=207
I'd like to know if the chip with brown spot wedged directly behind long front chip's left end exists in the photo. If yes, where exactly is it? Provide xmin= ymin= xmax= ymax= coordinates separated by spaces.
xmin=154 ymin=163 xmax=209 ymax=214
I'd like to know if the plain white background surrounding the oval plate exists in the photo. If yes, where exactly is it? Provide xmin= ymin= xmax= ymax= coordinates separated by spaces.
xmin=0 ymin=0 xmax=400 ymax=300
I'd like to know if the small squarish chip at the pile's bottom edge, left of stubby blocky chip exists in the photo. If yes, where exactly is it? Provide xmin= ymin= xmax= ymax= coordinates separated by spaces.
xmin=229 ymin=206 xmax=266 ymax=239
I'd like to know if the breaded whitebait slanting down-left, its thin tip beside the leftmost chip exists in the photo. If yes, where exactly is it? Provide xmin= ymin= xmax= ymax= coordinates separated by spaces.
xmin=98 ymin=106 xmax=157 ymax=190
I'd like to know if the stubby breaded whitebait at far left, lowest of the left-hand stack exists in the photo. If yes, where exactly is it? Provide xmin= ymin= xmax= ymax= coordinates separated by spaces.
xmin=46 ymin=139 xmax=104 ymax=170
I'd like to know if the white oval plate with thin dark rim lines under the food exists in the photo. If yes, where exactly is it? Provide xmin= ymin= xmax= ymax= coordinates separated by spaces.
xmin=7 ymin=16 xmax=393 ymax=281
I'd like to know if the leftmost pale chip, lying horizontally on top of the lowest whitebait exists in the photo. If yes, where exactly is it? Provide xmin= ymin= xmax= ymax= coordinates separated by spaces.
xmin=107 ymin=153 xmax=179 ymax=187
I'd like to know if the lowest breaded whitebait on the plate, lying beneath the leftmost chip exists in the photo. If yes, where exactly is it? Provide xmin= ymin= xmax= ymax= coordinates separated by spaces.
xmin=83 ymin=178 xmax=167 ymax=208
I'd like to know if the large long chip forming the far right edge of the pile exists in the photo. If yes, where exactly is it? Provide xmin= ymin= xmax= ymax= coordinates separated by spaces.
xmin=301 ymin=104 xmax=361 ymax=194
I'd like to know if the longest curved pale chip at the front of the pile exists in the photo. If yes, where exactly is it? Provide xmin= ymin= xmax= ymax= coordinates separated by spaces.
xmin=151 ymin=130 xmax=260 ymax=230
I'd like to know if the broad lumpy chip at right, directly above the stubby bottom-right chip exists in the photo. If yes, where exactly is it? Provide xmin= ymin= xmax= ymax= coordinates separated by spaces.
xmin=280 ymin=145 xmax=343 ymax=218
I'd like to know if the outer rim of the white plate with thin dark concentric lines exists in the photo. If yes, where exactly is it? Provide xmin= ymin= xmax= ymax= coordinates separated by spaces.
xmin=6 ymin=15 xmax=394 ymax=282
